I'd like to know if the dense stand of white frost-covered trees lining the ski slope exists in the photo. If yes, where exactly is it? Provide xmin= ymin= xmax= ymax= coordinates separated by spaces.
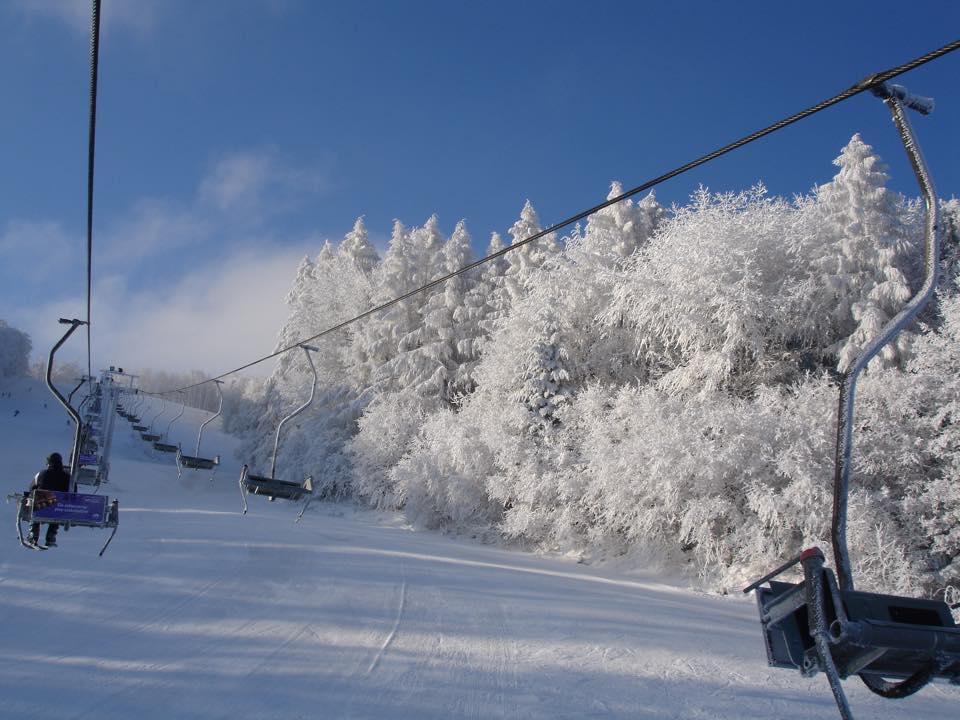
xmin=248 ymin=162 xmax=960 ymax=593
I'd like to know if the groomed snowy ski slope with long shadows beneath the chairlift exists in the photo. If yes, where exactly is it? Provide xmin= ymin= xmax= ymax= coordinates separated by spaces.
xmin=0 ymin=380 xmax=960 ymax=720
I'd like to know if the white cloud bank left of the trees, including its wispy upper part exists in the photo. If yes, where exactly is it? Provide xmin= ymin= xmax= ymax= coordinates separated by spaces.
xmin=0 ymin=150 xmax=338 ymax=372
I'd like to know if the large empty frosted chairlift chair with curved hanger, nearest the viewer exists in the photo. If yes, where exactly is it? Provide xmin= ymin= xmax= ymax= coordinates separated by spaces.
xmin=744 ymin=84 xmax=960 ymax=720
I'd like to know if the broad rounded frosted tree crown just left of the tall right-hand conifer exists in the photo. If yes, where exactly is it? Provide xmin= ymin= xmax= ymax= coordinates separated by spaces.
xmin=604 ymin=186 xmax=807 ymax=394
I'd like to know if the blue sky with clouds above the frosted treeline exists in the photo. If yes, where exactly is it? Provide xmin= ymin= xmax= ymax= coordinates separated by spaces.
xmin=0 ymin=0 xmax=960 ymax=372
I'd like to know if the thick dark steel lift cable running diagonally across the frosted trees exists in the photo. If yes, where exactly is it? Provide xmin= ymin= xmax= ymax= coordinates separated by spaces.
xmin=159 ymin=39 xmax=960 ymax=394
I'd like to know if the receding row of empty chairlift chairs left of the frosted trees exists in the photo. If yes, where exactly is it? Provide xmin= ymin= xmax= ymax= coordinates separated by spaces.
xmin=117 ymin=344 xmax=317 ymax=522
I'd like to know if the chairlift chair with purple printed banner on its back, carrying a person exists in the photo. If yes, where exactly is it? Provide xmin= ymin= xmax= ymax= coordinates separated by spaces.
xmin=7 ymin=319 xmax=120 ymax=556
